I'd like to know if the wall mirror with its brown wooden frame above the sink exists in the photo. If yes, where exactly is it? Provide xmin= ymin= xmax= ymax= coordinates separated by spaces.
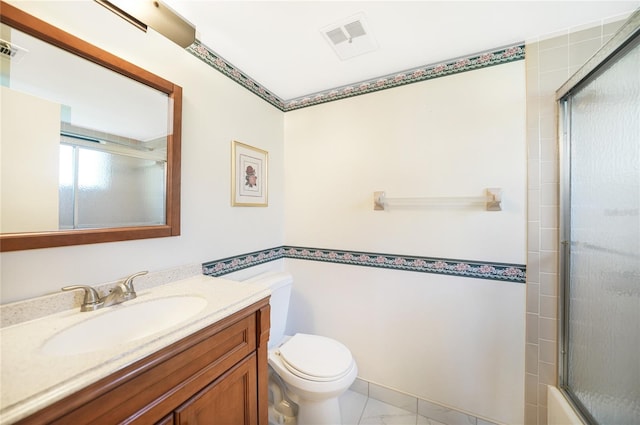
xmin=0 ymin=1 xmax=182 ymax=252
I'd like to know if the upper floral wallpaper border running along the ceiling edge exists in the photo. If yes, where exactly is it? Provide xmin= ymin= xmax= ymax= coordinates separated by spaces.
xmin=186 ymin=40 xmax=525 ymax=112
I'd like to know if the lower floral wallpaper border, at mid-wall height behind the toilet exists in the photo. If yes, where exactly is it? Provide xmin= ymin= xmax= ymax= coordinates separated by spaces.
xmin=202 ymin=246 xmax=526 ymax=283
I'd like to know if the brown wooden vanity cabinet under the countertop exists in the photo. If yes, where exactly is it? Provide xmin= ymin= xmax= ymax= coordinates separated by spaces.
xmin=18 ymin=298 xmax=269 ymax=425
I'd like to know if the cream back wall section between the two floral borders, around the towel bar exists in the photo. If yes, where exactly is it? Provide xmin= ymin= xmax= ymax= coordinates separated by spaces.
xmin=285 ymin=61 xmax=526 ymax=263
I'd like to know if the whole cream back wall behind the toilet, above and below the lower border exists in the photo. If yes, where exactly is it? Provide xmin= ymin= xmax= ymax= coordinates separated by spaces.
xmin=284 ymin=61 xmax=526 ymax=424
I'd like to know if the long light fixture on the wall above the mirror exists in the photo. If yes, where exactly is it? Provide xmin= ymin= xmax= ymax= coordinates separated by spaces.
xmin=95 ymin=0 xmax=196 ymax=48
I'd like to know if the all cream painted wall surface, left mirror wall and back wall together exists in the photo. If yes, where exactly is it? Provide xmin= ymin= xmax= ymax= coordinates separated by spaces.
xmin=0 ymin=1 xmax=525 ymax=423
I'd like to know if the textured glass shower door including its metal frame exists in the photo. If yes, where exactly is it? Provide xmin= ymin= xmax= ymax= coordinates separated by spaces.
xmin=558 ymin=12 xmax=640 ymax=425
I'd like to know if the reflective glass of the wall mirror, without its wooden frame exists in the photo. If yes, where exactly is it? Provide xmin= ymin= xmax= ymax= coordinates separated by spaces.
xmin=0 ymin=27 xmax=169 ymax=233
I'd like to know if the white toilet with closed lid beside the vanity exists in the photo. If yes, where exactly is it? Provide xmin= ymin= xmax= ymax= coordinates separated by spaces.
xmin=247 ymin=272 xmax=358 ymax=425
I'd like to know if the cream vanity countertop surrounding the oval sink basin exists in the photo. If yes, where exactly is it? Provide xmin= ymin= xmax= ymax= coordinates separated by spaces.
xmin=0 ymin=275 xmax=270 ymax=424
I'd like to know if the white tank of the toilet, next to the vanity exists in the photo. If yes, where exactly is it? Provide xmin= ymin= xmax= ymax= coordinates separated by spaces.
xmin=245 ymin=272 xmax=293 ymax=348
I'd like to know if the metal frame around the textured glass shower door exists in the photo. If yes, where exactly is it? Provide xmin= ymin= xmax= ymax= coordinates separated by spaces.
xmin=556 ymin=9 xmax=640 ymax=424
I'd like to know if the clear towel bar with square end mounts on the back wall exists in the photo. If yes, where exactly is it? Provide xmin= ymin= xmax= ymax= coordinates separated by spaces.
xmin=373 ymin=188 xmax=502 ymax=211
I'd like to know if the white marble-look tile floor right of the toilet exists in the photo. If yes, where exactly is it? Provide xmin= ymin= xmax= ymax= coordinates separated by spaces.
xmin=340 ymin=390 xmax=444 ymax=425
